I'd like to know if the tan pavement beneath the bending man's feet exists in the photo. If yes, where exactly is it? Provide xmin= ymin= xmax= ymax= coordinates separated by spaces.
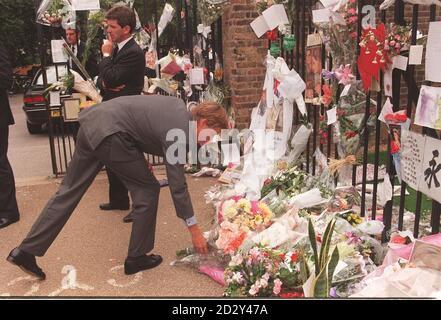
xmin=0 ymin=168 xmax=223 ymax=298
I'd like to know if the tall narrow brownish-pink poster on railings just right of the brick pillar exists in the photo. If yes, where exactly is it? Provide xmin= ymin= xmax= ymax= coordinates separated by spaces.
xmin=305 ymin=34 xmax=322 ymax=105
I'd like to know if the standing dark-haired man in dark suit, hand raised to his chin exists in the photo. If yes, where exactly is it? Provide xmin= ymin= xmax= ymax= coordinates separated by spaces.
xmin=98 ymin=6 xmax=145 ymax=215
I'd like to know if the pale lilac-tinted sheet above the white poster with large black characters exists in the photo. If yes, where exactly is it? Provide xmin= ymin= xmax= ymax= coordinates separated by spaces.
xmin=415 ymin=86 xmax=441 ymax=130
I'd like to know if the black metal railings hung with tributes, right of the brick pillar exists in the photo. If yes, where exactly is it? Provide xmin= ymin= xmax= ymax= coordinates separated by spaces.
xmin=280 ymin=0 xmax=441 ymax=241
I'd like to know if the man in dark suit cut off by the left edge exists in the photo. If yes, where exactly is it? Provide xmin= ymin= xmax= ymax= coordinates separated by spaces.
xmin=0 ymin=44 xmax=20 ymax=229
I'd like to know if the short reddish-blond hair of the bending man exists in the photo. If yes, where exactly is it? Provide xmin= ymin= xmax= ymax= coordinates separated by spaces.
xmin=191 ymin=102 xmax=228 ymax=130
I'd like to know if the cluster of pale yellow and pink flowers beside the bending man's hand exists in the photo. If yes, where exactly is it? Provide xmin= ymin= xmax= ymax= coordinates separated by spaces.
xmin=216 ymin=197 xmax=274 ymax=253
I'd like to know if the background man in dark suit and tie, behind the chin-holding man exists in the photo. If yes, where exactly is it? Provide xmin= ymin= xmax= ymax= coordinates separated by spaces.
xmin=66 ymin=25 xmax=99 ymax=79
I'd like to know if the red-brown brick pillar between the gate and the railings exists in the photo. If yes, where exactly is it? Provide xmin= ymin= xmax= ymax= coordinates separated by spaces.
xmin=222 ymin=0 xmax=268 ymax=129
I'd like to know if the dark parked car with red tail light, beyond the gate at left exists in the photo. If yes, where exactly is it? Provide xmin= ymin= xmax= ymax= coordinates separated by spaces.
xmin=23 ymin=65 xmax=68 ymax=134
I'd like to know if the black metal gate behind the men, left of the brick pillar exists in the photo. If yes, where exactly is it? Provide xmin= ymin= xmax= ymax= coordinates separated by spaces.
xmin=35 ymin=0 xmax=223 ymax=176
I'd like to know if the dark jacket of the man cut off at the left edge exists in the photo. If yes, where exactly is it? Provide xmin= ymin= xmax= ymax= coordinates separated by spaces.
xmin=0 ymin=45 xmax=14 ymax=126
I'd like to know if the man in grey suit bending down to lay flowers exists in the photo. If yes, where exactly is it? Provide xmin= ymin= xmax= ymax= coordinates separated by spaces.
xmin=7 ymin=96 xmax=228 ymax=279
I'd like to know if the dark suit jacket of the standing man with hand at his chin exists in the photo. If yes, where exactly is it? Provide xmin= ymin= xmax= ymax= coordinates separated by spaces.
xmin=98 ymin=38 xmax=145 ymax=101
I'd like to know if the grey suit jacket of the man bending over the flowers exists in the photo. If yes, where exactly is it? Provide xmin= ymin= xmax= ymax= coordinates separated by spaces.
xmin=79 ymin=95 xmax=194 ymax=219
